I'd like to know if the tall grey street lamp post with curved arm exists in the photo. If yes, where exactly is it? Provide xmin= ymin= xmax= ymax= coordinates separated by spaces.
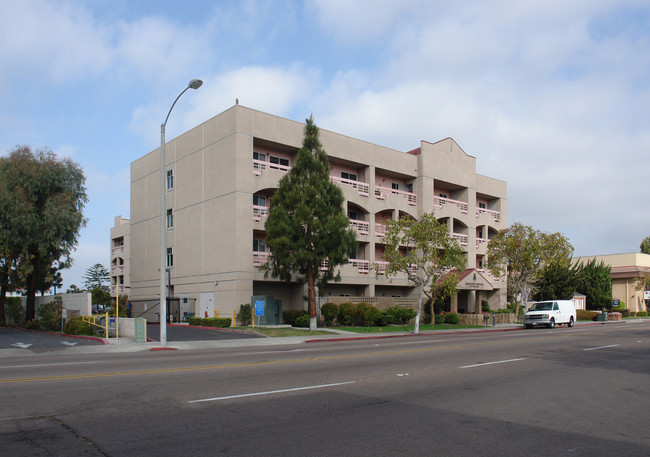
xmin=160 ymin=79 xmax=203 ymax=346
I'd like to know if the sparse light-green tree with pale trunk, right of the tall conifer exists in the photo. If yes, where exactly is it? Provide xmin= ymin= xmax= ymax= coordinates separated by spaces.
xmin=384 ymin=213 xmax=465 ymax=334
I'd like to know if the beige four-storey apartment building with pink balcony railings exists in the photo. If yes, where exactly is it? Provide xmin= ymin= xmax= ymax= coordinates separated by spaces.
xmin=117 ymin=105 xmax=507 ymax=316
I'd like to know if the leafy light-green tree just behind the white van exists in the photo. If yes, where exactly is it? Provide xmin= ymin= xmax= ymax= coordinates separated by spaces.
xmin=487 ymin=223 xmax=573 ymax=316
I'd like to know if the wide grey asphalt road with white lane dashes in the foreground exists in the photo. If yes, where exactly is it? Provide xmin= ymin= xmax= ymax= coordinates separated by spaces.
xmin=0 ymin=323 xmax=650 ymax=457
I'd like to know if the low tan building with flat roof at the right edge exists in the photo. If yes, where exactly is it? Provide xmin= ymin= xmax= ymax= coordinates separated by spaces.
xmin=573 ymin=252 xmax=650 ymax=312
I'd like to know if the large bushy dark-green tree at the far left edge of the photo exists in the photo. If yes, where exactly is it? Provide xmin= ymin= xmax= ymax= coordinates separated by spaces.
xmin=0 ymin=146 xmax=88 ymax=320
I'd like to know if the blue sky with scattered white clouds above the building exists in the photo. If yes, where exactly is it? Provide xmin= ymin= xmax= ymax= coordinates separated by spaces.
xmin=0 ymin=0 xmax=650 ymax=290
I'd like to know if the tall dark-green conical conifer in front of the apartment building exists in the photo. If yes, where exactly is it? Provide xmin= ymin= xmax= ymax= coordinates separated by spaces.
xmin=264 ymin=116 xmax=357 ymax=330
